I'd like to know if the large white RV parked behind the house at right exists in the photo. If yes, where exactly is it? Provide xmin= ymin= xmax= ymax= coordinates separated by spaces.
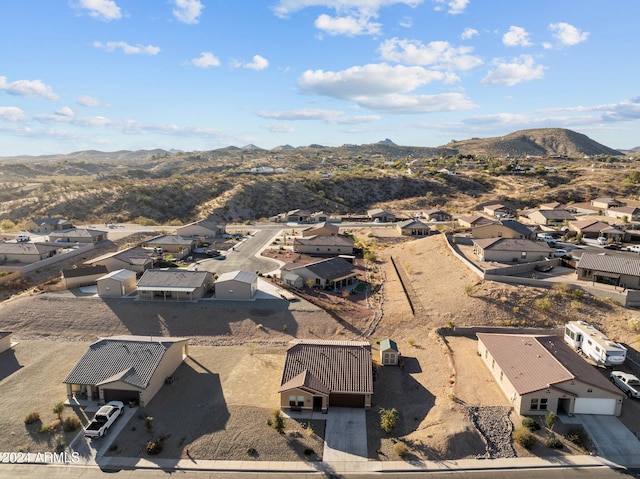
xmin=564 ymin=321 xmax=627 ymax=366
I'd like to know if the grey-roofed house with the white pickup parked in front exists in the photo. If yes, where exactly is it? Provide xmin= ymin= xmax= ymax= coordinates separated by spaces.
xmin=63 ymin=336 xmax=189 ymax=407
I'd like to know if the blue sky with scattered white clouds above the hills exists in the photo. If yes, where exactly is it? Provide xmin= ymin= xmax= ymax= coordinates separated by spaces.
xmin=0 ymin=0 xmax=640 ymax=156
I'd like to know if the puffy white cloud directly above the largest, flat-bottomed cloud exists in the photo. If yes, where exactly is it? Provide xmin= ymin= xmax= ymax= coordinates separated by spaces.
xmin=379 ymin=38 xmax=482 ymax=70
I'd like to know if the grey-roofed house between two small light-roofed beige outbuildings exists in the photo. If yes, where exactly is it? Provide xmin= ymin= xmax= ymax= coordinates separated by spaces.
xmin=137 ymin=268 xmax=213 ymax=301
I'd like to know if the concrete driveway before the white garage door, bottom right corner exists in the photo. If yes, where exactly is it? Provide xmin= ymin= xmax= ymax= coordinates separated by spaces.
xmin=575 ymin=414 xmax=640 ymax=467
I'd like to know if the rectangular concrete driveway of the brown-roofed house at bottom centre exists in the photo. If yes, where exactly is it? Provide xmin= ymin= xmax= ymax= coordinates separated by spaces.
xmin=322 ymin=407 xmax=367 ymax=462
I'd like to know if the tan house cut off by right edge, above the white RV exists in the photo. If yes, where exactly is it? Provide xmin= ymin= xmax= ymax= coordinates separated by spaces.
xmin=576 ymin=253 xmax=640 ymax=289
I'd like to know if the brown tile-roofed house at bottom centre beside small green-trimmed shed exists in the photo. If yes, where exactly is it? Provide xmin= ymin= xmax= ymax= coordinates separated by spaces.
xmin=278 ymin=339 xmax=373 ymax=412
